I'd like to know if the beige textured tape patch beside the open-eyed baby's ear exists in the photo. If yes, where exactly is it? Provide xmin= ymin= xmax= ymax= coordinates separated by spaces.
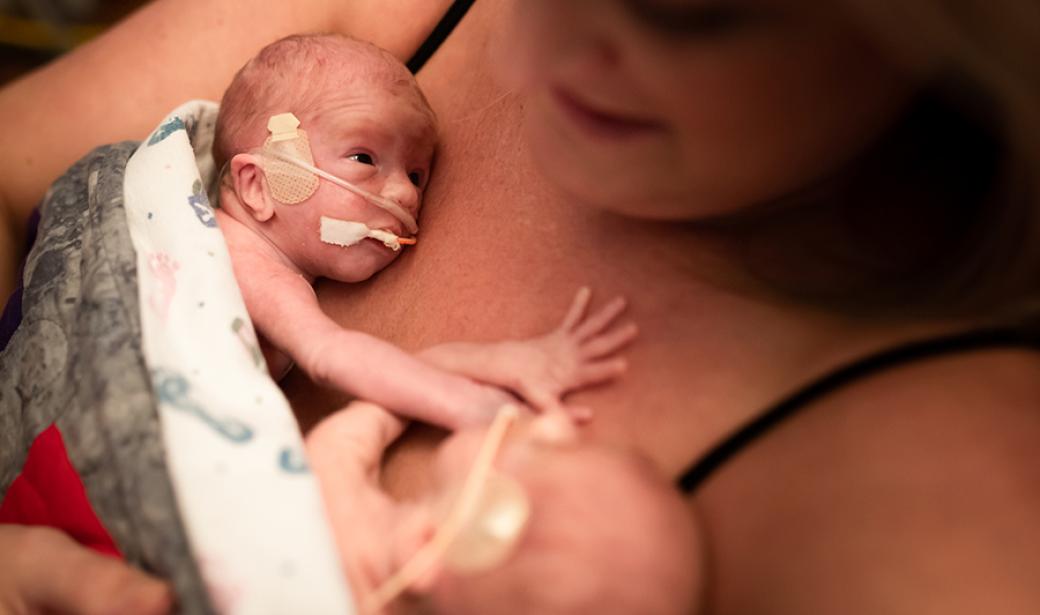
xmin=262 ymin=113 xmax=318 ymax=205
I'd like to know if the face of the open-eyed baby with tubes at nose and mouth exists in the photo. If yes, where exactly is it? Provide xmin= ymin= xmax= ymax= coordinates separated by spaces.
xmin=279 ymin=83 xmax=436 ymax=282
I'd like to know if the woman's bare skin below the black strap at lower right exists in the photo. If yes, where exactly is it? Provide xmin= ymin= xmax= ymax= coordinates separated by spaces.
xmin=697 ymin=350 xmax=1040 ymax=613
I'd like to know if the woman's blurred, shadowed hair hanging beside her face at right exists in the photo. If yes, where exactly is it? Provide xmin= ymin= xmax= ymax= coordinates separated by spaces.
xmin=712 ymin=0 xmax=1040 ymax=327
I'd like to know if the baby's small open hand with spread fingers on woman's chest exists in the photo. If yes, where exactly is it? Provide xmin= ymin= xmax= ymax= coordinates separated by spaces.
xmin=496 ymin=288 xmax=639 ymax=419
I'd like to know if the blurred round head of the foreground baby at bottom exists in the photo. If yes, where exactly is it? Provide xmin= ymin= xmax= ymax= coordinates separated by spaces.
xmin=378 ymin=413 xmax=701 ymax=615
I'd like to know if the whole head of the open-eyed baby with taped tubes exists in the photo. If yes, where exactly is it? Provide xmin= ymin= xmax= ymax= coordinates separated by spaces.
xmin=213 ymin=34 xmax=437 ymax=282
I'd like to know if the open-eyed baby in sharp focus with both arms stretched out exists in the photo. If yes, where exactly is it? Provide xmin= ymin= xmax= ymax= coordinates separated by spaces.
xmin=214 ymin=35 xmax=635 ymax=428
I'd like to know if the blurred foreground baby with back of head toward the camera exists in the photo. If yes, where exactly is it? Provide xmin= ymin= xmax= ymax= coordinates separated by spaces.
xmin=307 ymin=403 xmax=700 ymax=615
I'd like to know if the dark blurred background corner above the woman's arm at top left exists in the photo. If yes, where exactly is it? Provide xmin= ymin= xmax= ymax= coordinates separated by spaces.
xmin=0 ymin=0 xmax=145 ymax=85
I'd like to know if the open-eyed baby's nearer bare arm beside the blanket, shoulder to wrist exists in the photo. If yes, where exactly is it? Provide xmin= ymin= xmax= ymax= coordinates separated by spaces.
xmin=233 ymin=253 xmax=512 ymax=429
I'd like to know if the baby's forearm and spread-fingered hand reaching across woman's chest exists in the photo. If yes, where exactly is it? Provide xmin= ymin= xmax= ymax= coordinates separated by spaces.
xmin=418 ymin=288 xmax=638 ymax=413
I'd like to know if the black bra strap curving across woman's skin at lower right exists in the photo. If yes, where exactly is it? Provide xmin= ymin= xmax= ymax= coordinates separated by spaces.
xmin=678 ymin=329 xmax=1040 ymax=493
